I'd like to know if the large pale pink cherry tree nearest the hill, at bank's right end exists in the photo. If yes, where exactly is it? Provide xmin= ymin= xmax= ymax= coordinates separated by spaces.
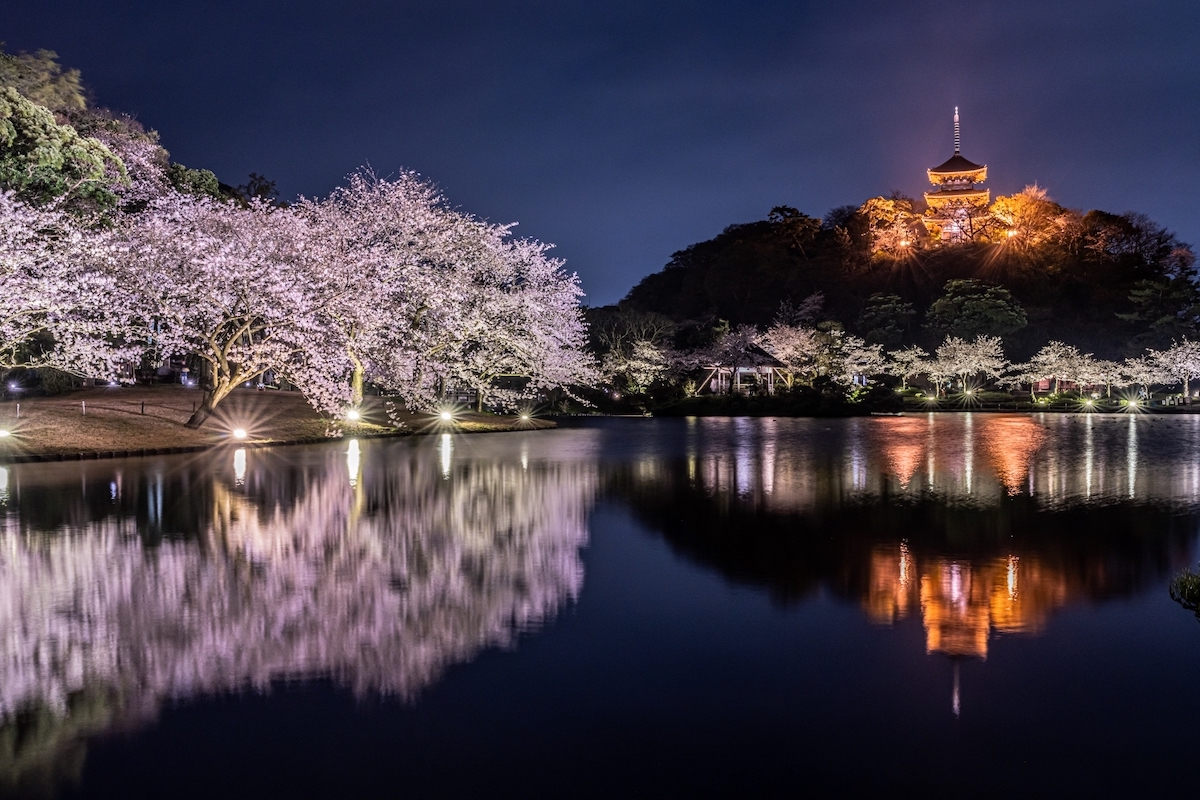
xmin=298 ymin=172 xmax=595 ymax=410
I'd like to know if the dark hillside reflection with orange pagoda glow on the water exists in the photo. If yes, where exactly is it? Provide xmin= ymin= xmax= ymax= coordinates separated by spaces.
xmin=607 ymin=415 xmax=1200 ymax=609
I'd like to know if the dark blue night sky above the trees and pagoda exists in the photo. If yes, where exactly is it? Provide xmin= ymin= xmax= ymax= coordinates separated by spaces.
xmin=0 ymin=0 xmax=1200 ymax=305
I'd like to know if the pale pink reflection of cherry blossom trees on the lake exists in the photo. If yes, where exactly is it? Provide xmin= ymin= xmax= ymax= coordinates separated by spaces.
xmin=0 ymin=439 xmax=596 ymax=796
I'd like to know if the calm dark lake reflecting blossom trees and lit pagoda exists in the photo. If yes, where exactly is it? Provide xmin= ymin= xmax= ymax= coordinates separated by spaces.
xmin=0 ymin=414 xmax=1200 ymax=798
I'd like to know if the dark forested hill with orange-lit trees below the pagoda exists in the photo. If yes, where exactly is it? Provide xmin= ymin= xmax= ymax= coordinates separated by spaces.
xmin=614 ymin=194 xmax=1200 ymax=357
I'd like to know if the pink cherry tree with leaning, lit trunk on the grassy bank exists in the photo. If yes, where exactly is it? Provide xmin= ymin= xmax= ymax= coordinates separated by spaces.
xmin=125 ymin=193 xmax=337 ymax=428
